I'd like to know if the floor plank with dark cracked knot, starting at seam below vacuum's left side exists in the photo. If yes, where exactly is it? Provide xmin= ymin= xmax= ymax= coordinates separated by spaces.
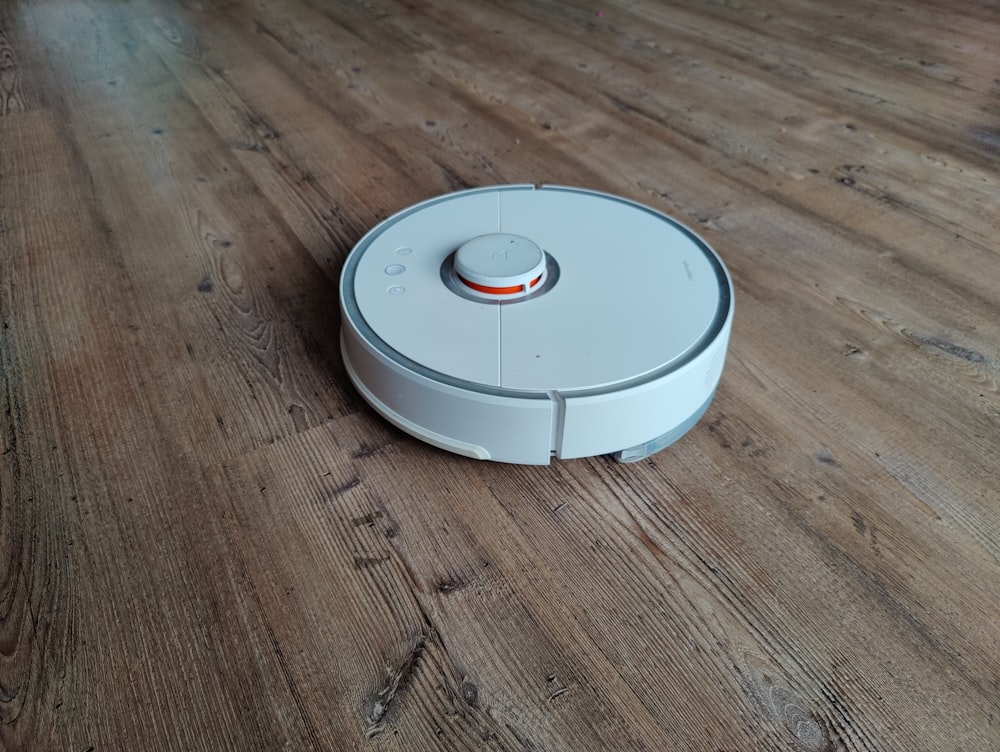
xmin=211 ymin=418 xmax=676 ymax=749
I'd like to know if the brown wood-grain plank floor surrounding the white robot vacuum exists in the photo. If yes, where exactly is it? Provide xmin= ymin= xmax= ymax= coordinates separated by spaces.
xmin=0 ymin=0 xmax=1000 ymax=752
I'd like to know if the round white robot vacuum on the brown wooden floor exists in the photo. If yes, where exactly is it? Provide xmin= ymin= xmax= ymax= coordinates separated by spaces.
xmin=340 ymin=185 xmax=733 ymax=465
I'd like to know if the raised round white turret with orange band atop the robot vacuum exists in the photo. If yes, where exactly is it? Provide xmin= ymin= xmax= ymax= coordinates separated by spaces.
xmin=454 ymin=233 xmax=546 ymax=299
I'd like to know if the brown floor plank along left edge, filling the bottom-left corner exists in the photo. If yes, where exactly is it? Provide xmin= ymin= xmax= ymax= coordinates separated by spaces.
xmin=0 ymin=104 xmax=320 ymax=749
